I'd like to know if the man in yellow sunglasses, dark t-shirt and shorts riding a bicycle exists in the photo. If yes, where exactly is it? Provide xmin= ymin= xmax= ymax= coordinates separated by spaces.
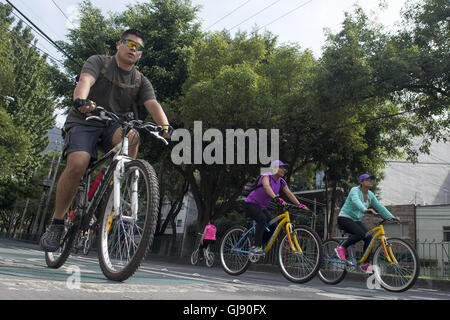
xmin=40 ymin=29 xmax=170 ymax=252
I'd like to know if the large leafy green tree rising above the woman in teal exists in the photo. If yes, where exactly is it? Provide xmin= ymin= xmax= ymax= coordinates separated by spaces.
xmin=304 ymin=1 xmax=449 ymax=236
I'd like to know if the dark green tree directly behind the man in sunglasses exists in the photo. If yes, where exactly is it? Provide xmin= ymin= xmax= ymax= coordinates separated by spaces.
xmin=55 ymin=0 xmax=204 ymax=233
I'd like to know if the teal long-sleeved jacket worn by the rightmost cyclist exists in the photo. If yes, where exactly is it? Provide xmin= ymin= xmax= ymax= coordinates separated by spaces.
xmin=339 ymin=187 xmax=394 ymax=221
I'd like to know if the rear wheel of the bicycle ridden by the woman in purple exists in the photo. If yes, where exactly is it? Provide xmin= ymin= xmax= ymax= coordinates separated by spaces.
xmin=220 ymin=227 xmax=251 ymax=276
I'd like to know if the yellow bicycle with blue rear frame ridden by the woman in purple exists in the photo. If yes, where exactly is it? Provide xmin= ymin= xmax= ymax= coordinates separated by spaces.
xmin=220 ymin=204 xmax=322 ymax=283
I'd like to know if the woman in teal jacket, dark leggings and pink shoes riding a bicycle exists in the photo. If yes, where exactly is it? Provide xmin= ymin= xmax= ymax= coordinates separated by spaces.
xmin=335 ymin=173 xmax=400 ymax=273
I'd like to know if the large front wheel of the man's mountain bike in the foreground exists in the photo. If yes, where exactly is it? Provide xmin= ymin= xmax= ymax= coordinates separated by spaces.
xmin=98 ymin=160 xmax=159 ymax=281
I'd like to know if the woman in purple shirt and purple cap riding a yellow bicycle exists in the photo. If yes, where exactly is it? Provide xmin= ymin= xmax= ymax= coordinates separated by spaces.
xmin=244 ymin=160 xmax=307 ymax=255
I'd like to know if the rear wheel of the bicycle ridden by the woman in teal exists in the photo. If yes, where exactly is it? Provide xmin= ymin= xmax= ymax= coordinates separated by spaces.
xmin=318 ymin=239 xmax=347 ymax=284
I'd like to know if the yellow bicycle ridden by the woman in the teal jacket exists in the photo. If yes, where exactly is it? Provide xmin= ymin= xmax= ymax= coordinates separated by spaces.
xmin=319 ymin=215 xmax=419 ymax=292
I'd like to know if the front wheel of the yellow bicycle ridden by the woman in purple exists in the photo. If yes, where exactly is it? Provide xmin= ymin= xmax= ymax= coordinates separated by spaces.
xmin=278 ymin=226 xmax=322 ymax=283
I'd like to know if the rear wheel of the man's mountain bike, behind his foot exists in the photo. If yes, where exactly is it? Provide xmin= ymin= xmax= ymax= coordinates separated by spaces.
xmin=45 ymin=193 xmax=81 ymax=269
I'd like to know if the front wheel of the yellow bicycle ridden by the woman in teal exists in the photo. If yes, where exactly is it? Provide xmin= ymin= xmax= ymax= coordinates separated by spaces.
xmin=373 ymin=238 xmax=419 ymax=292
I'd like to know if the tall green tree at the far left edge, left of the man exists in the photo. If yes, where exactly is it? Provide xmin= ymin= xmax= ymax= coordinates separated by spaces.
xmin=0 ymin=4 xmax=56 ymax=207
